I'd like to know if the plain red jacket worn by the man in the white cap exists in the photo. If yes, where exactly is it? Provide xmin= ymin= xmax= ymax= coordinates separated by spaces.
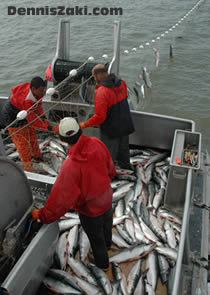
xmin=39 ymin=135 xmax=116 ymax=223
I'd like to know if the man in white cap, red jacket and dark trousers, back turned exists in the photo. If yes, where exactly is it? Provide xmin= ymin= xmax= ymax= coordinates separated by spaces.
xmin=32 ymin=117 xmax=116 ymax=269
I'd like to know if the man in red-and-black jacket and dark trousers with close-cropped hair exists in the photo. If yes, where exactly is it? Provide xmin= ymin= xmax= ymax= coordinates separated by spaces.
xmin=80 ymin=64 xmax=134 ymax=169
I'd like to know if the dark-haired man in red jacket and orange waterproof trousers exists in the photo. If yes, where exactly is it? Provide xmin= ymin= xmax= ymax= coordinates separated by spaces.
xmin=2 ymin=77 xmax=58 ymax=171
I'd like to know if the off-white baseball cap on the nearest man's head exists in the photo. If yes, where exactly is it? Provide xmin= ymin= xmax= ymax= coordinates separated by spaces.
xmin=59 ymin=117 xmax=80 ymax=137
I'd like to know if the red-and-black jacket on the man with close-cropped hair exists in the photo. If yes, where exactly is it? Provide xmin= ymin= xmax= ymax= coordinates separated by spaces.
xmin=85 ymin=74 xmax=134 ymax=138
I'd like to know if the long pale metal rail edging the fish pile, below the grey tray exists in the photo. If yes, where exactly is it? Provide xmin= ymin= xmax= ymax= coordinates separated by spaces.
xmin=172 ymin=169 xmax=192 ymax=295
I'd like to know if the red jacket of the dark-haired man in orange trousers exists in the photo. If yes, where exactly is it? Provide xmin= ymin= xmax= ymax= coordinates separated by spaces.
xmin=10 ymin=82 xmax=49 ymax=129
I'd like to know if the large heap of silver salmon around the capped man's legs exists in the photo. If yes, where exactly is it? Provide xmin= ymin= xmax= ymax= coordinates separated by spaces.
xmin=34 ymin=149 xmax=181 ymax=295
